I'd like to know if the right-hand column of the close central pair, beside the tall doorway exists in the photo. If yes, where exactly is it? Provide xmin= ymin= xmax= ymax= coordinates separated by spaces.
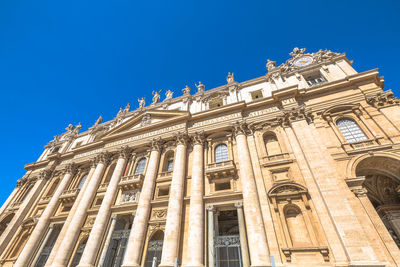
xmin=183 ymin=133 xmax=204 ymax=266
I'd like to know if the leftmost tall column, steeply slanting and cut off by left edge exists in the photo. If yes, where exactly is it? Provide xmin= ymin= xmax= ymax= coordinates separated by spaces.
xmin=0 ymin=169 xmax=52 ymax=254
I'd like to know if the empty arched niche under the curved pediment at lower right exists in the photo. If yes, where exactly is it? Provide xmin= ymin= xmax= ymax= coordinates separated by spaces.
xmin=285 ymin=206 xmax=311 ymax=247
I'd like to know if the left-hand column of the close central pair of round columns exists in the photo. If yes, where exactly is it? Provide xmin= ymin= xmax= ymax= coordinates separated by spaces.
xmin=160 ymin=133 xmax=187 ymax=266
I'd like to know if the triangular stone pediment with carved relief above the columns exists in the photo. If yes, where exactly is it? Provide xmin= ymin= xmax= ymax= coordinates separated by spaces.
xmin=103 ymin=110 xmax=190 ymax=139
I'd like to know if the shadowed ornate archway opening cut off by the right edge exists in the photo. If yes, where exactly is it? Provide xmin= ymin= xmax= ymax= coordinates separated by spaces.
xmin=355 ymin=156 xmax=400 ymax=247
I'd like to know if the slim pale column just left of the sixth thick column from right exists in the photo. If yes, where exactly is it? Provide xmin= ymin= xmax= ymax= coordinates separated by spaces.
xmin=45 ymin=162 xmax=96 ymax=267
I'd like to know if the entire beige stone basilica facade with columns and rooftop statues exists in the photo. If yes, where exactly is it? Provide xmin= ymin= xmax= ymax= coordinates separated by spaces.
xmin=0 ymin=48 xmax=400 ymax=267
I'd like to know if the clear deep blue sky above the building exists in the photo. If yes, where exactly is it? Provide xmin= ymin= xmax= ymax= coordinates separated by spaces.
xmin=0 ymin=0 xmax=400 ymax=203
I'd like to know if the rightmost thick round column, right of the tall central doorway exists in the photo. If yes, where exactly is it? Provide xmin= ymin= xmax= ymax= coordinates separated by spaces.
xmin=234 ymin=122 xmax=271 ymax=266
